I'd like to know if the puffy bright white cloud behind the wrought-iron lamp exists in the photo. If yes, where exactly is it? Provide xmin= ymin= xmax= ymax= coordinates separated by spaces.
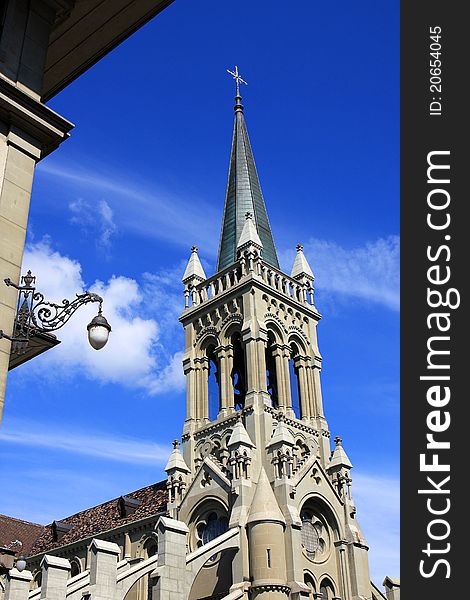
xmin=24 ymin=240 xmax=184 ymax=395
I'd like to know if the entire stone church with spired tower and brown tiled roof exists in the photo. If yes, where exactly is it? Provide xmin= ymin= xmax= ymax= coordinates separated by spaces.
xmin=0 ymin=69 xmax=400 ymax=600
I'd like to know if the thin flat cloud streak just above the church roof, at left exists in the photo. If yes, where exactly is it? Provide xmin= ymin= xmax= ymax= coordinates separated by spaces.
xmin=0 ymin=420 xmax=171 ymax=467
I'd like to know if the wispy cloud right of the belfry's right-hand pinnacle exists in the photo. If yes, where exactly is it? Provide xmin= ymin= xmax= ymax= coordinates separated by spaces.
xmin=281 ymin=236 xmax=400 ymax=311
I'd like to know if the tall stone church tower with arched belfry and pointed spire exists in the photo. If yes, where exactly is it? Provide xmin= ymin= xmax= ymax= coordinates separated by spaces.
xmin=166 ymin=72 xmax=372 ymax=600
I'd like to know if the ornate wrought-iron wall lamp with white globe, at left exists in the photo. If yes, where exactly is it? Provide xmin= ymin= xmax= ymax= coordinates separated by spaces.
xmin=0 ymin=271 xmax=111 ymax=354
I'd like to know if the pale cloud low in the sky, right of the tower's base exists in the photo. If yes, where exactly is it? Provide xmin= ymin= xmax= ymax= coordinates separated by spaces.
xmin=352 ymin=473 xmax=400 ymax=588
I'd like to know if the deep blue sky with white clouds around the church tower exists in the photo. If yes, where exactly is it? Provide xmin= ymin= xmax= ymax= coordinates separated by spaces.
xmin=0 ymin=0 xmax=399 ymax=583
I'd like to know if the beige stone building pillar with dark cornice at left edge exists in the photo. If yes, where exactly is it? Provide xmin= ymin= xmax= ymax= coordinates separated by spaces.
xmin=0 ymin=0 xmax=73 ymax=419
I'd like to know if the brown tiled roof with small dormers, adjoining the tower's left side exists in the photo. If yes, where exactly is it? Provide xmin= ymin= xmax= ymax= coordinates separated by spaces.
xmin=28 ymin=479 xmax=168 ymax=556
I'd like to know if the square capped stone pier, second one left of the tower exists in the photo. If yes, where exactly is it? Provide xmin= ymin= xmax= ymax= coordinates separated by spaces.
xmin=90 ymin=539 xmax=120 ymax=600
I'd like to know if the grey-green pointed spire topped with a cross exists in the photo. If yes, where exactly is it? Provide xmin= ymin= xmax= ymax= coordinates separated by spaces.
xmin=217 ymin=67 xmax=279 ymax=271
